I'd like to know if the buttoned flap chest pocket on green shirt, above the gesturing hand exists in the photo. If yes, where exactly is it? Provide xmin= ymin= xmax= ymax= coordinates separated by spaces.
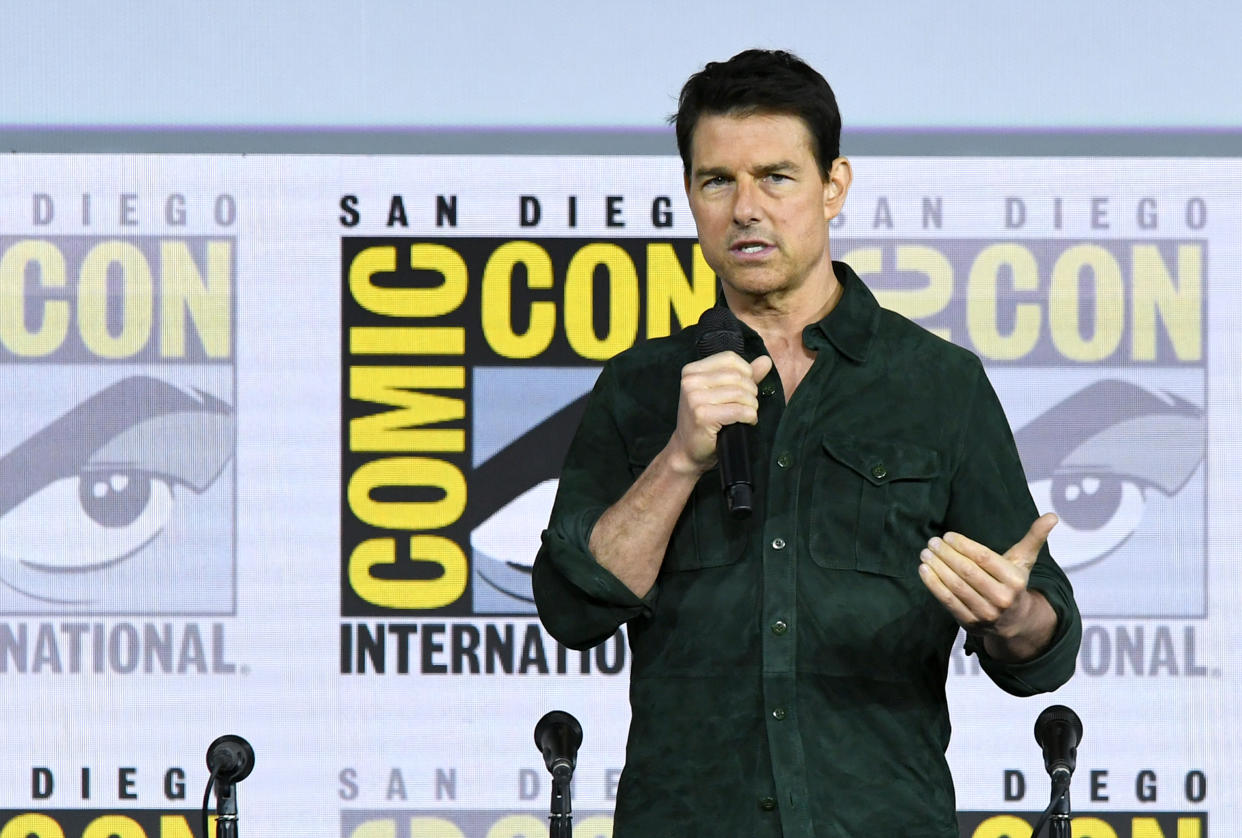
xmin=809 ymin=433 xmax=945 ymax=576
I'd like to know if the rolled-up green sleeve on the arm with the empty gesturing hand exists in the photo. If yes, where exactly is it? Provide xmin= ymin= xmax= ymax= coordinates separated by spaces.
xmin=946 ymin=366 xmax=1082 ymax=695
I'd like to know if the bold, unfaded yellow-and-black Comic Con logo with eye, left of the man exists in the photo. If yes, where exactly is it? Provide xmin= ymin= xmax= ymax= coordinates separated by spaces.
xmin=342 ymin=237 xmax=715 ymax=616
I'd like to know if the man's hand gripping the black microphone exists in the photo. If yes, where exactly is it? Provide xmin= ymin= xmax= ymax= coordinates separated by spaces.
xmin=668 ymin=351 xmax=773 ymax=475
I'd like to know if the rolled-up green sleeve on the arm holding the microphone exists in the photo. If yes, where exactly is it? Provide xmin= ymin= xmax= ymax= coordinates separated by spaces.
xmin=532 ymin=366 xmax=656 ymax=649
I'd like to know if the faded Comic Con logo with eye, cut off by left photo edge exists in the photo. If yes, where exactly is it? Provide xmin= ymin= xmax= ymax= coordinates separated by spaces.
xmin=0 ymin=237 xmax=236 ymax=615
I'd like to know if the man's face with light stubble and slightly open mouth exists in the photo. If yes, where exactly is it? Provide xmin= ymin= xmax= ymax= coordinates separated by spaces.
xmin=686 ymin=113 xmax=848 ymax=305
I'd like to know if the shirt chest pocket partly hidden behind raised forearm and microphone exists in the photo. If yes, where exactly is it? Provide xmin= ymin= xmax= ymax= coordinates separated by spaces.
xmin=630 ymin=436 xmax=755 ymax=572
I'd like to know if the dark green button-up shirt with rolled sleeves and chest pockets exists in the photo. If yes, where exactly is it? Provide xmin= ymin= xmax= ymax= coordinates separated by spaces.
xmin=534 ymin=262 xmax=1082 ymax=838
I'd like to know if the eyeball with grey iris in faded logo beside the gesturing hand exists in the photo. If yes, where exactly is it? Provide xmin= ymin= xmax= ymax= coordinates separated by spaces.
xmin=1030 ymin=473 xmax=1146 ymax=570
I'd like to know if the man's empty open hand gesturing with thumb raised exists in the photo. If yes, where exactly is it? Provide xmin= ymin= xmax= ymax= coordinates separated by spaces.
xmin=919 ymin=513 xmax=1057 ymax=662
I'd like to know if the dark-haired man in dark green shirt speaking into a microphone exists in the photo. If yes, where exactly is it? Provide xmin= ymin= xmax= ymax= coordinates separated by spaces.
xmin=534 ymin=50 xmax=1082 ymax=838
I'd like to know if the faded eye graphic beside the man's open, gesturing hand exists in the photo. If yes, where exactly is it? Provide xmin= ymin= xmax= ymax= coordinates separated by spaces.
xmin=1015 ymin=379 xmax=1207 ymax=616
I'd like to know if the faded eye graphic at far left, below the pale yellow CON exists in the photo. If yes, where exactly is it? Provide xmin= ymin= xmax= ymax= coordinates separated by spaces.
xmin=0 ymin=376 xmax=235 ymax=615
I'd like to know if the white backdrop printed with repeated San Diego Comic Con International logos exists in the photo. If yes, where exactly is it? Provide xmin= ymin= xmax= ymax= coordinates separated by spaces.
xmin=0 ymin=155 xmax=1242 ymax=838
